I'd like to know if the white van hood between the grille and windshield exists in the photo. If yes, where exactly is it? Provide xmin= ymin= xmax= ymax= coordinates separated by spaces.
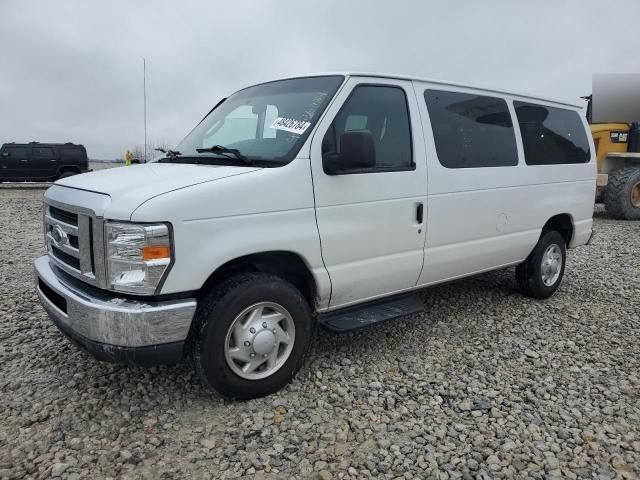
xmin=56 ymin=163 xmax=260 ymax=220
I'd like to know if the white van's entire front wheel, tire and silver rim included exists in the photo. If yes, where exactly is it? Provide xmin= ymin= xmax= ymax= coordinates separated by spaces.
xmin=191 ymin=273 xmax=311 ymax=399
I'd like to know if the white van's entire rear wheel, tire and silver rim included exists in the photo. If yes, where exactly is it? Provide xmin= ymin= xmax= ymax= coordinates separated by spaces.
xmin=516 ymin=230 xmax=567 ymax=299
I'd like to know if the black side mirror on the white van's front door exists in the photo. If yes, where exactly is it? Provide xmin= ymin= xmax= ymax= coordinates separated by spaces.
xmin=322 ymin=130 xmax=376 ymax=175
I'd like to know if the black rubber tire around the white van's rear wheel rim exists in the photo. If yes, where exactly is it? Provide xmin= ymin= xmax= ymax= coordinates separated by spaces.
xmin=516 ymin=230 xmax=567 ymax=299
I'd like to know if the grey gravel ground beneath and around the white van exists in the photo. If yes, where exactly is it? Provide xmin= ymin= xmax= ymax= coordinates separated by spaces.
xmin=0 ymin=189 xmax=640 ymax=479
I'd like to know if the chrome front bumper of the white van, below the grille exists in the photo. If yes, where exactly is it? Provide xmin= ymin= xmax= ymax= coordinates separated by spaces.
xmin=35 ymin=255 xmax=196 ymax=364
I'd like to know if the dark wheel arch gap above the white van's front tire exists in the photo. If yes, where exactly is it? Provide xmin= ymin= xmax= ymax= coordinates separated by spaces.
xmin=196 ymin=250 xmax=318 ymax=309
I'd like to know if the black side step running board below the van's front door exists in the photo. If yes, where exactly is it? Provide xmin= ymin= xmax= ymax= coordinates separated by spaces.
xmin=318 ymin=294 xmax=424 ymax=333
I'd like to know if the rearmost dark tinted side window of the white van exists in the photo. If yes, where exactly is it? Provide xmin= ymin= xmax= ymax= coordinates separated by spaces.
xmin=513 ymin=102 xmax=591 ymax=165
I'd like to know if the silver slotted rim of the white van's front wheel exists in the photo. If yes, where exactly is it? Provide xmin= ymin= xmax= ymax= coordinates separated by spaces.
xmin=224 ymin=302 xmax=295 ymax=380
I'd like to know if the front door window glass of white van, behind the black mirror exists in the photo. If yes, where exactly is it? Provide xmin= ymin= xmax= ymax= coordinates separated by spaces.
xmin=322 ymin=85 xmax=412 ymax=171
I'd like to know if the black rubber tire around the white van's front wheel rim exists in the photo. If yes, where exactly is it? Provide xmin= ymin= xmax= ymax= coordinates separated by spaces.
xmin=189 ymin=273 xmax=312 ymax=400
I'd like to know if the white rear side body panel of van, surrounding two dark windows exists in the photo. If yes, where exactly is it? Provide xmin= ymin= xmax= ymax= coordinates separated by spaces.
xmin=414 ymin=82 xmax=596 ymax=285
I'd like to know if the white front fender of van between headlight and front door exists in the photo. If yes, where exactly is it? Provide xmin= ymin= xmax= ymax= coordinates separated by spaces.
xmin=131 ymin=158 xmax=331 ymax=305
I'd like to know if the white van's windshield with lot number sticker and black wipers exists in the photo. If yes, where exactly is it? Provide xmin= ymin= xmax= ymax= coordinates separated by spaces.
xmin=172 ymin=76 xmax=343 ymax=164
